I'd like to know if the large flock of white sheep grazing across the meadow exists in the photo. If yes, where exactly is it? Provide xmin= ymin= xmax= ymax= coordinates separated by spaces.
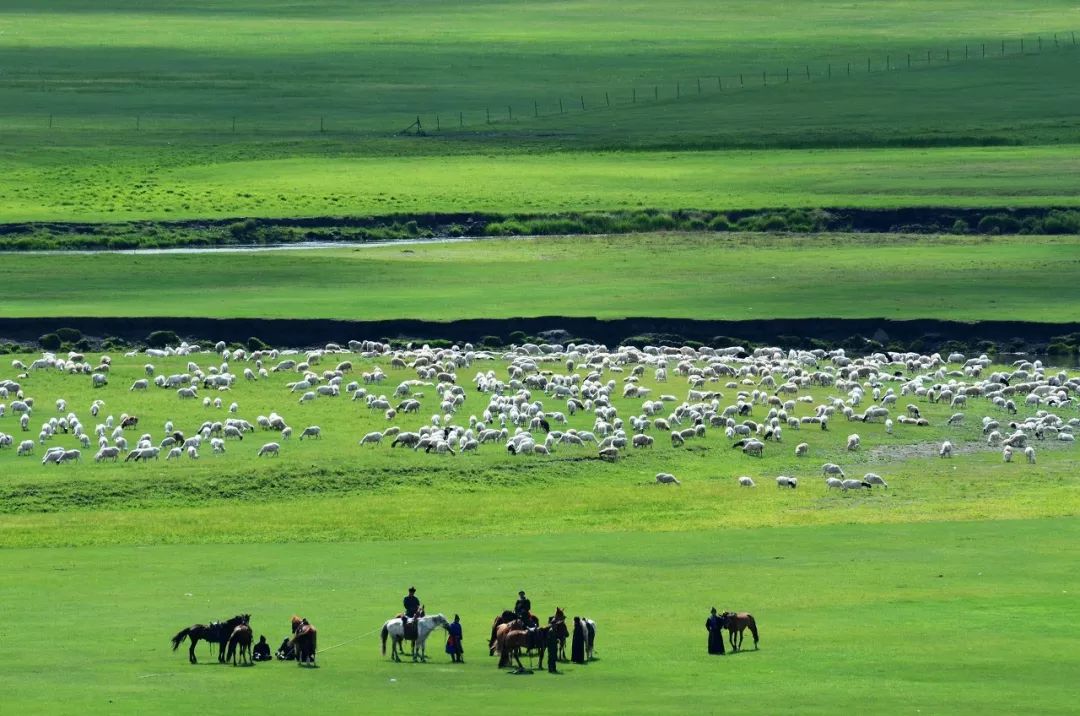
xmin=0 ymin=340 xmax=1080 ymax=494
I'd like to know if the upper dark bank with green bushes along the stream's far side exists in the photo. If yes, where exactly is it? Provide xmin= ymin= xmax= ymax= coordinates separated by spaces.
xmin=0 ymin=206 xmax=1080 ymax=252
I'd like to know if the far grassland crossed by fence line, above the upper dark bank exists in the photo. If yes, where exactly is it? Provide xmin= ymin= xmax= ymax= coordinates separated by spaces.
xmin=0 ymin=0 xmax=1080 ymax=221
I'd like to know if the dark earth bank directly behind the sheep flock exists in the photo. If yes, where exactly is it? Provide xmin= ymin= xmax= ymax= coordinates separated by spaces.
xmin=0 ymin=316 xmax=1080 ymax=352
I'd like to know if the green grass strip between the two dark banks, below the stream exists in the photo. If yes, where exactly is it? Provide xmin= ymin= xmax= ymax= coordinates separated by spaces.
xmin=0 ymin=233 xmax=1080 ymax=323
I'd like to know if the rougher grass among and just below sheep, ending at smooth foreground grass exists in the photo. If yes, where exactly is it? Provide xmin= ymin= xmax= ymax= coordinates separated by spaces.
xmin=0 ymin=347 xmax=1080 ymax=545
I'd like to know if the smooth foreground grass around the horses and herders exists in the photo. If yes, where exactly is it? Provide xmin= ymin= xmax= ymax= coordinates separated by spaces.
xmin=0 ymin=520 xmax=1080 ymax=714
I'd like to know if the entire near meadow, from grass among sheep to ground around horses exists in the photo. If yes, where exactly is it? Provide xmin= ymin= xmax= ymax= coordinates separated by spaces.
xmin=0 ymin=347 xmax=1080 ymax=714
